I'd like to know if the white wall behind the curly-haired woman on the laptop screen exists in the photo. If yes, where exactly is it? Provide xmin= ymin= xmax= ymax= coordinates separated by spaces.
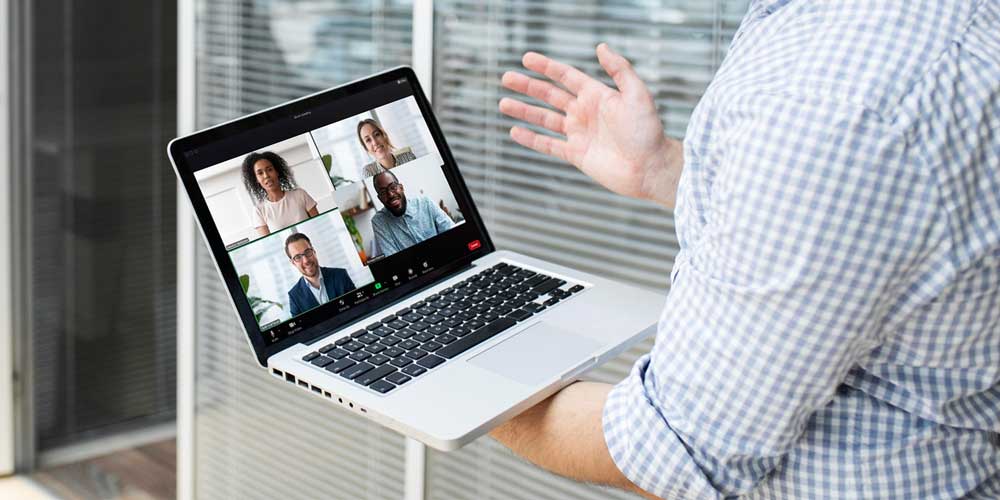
xmin=195 ymin=134 xmax=337 ymax=245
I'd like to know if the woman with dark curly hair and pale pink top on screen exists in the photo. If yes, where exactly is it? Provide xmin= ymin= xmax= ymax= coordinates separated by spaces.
xmin=243 ymin=151 xmax=319 ymax=236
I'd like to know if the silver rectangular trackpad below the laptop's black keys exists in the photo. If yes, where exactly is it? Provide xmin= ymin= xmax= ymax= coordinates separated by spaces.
xmin=469 ymin=321 xmax=601 ymax=385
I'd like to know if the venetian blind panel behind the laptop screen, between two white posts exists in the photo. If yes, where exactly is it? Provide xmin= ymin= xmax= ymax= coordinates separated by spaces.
xmin=194 ymin=0 xmax=413 ymax=499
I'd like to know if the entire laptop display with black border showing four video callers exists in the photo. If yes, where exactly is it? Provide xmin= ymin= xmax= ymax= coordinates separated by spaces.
xmin=171 ymin=68 xmax=489 ymax=362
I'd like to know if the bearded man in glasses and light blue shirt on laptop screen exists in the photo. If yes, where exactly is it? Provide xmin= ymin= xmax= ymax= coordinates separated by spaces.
xmin=372 ymin=170 xmax=455 ymax=256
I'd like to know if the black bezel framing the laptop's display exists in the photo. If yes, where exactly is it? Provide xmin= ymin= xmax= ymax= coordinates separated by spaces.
xmin=173 ymin=66 xmax=495 ymax=366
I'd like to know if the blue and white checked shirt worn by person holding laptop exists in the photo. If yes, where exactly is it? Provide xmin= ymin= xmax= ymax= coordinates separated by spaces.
xmin=604 ymin=0 xmax=1000 ymax=499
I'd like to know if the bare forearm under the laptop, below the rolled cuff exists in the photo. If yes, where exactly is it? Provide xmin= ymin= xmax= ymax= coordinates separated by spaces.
xmin=490 ymin=382 xmax=656 ymax=498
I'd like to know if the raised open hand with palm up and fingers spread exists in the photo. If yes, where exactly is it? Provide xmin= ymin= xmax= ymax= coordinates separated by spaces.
xmin=500 ymin=43 xmax=684 ymax=208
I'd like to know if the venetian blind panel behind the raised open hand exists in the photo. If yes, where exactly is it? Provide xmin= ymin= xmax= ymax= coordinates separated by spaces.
xmin=428 ymin=0 xmax=747 ymax=500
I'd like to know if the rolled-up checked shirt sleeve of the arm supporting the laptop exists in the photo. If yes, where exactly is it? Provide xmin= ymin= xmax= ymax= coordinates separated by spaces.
xmin=603 ymin=95 xmax=936 ymax=498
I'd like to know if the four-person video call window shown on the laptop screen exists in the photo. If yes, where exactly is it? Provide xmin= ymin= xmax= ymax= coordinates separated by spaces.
xmin=194 ymin=85 xmax=478 ymax=344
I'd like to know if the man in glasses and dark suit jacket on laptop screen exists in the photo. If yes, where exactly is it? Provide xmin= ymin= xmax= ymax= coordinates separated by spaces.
xmin=285 ymin=233 xmax=356 ymax=317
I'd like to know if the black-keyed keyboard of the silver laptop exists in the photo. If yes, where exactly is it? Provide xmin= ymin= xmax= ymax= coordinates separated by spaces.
xmin=302 ymin=263 xmax=583 ymax=394
